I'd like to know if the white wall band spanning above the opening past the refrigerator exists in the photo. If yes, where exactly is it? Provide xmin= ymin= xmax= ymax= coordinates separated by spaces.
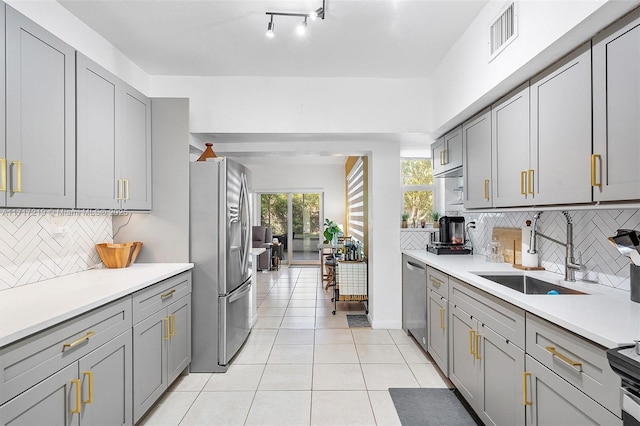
xmin=151 ymin=76 xmax=431 ymax=133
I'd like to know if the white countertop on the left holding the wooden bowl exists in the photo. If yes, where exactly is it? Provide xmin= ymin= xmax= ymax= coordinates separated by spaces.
xmin=0 ymin=263 xmax=193 ymax=347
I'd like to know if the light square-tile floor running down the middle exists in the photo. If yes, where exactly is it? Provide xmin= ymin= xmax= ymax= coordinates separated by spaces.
xmin=141 ymin=267 xmax=447 ymax=426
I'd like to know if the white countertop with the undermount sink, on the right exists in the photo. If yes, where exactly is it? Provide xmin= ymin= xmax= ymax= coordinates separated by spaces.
xmin=403 ymin=250 xmax=640 ymax=348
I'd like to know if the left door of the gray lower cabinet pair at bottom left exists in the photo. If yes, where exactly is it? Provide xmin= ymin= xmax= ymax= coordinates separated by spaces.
xmin=0 ymin=362 xmax=82 ymax=426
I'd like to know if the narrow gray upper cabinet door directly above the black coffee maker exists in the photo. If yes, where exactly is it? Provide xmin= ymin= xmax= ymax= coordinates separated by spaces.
xmin=462 ymin=110 xmax=493 ymax=208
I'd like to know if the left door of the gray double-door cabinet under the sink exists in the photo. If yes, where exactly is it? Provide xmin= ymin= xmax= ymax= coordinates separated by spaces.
xmin=449 ymin=303 xmax=480 ymax=408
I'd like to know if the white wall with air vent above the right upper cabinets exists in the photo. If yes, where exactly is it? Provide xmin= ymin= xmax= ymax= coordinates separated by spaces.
xmin=430 ymin=0 xmax=640 ymax=133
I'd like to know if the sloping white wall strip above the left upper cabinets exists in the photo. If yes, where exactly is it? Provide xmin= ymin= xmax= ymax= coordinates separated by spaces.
xmin=5 ymin=0 xmax=149 ymax=95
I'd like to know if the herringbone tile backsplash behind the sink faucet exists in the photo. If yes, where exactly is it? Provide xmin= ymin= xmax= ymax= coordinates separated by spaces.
xmin=464 ymin=209 xmax=640 ymax=291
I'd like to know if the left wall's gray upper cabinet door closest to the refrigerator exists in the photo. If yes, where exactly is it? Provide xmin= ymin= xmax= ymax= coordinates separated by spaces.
xmin=116 ymin=85 xmax=151 ymax=210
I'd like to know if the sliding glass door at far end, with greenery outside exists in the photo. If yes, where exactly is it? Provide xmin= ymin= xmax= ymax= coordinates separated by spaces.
xmin=260 ymin=192 xmax=322 ymax=265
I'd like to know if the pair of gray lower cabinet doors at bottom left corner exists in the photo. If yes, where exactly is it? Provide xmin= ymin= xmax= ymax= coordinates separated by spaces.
xmin=0 ymin=330 xmax=132 ymax=426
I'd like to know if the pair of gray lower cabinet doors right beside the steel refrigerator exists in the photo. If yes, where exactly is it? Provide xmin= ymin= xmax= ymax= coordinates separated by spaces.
xmin=133 ymin=289 xmax=191 ymax=422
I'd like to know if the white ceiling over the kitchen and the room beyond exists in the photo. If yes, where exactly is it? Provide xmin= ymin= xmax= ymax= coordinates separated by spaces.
xmin=58 ymin=0 xmax=488 ymax=161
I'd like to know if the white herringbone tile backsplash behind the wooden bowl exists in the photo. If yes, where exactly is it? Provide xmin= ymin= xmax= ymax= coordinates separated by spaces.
xmin=0 ymin=209 xmax=113 ymax=290
